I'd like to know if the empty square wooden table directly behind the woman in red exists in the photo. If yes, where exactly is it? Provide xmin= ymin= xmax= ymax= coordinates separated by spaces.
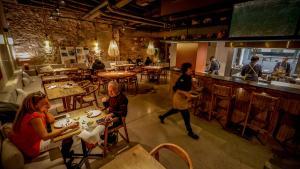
xmin=44 ymin=81 xmax=85 ymax=111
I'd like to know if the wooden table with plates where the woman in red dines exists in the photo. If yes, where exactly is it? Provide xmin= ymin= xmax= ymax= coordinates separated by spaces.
xmin=52 ymin=106 xmax=106 ymax=142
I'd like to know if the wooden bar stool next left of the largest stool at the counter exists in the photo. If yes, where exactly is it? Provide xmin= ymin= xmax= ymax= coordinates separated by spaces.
xmin=208 ymin=84 xmax=234 ymax=128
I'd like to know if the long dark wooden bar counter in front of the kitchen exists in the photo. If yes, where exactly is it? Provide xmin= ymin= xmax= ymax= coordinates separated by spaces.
xmin=169 ymin=70 xmax=300 ymax=142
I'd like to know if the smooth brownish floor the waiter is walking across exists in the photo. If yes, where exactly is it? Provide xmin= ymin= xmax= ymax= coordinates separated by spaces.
xmin=51 ymin=80 xmax=272 ymax=169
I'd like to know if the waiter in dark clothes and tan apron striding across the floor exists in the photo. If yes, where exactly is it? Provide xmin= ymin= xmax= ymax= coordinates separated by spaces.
xmin=159 ymin=63 xmax=199 ymax=139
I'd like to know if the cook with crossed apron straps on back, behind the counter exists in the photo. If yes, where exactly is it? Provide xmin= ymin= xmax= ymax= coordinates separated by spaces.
xmin=241 ymin=56 xmax=262 ymax=82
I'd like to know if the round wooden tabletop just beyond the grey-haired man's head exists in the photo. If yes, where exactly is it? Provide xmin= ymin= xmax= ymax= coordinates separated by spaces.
xmin=97 ymin=71 xmax=136 ymax=80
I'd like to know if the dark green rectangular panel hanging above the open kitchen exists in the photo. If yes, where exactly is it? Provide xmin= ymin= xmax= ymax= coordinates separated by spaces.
xmin=229 ymin=0 xmax=300 ymax=37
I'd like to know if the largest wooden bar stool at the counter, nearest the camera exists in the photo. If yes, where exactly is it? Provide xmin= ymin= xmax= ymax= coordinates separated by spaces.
xmin=242 ymin=92 xmax=279 ymax=141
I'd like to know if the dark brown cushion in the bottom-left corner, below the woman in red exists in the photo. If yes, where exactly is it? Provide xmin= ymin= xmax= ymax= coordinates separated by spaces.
xmin=1 ymin=139 xmax=24 ymax=169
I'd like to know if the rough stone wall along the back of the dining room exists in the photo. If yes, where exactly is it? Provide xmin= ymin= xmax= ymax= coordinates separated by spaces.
xmin=4 ymin=4 xmax=163 ymax=64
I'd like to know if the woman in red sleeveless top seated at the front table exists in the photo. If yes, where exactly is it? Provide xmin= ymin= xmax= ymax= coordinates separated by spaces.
xmin=10 ymin=92 xmax=78 ymax=158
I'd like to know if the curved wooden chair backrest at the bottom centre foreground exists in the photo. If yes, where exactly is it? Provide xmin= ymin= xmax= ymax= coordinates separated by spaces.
xmin=150 ymin=143 xmax=193 ymax=169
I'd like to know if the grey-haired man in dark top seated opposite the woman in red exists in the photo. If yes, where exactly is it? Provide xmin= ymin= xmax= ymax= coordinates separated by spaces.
xmin=102 ymin=81 xmax=128 ymax=143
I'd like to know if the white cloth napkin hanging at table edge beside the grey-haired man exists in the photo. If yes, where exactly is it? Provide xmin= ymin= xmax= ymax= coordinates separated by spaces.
xmin=78 ymin=125 xmax=105 ymax=144
